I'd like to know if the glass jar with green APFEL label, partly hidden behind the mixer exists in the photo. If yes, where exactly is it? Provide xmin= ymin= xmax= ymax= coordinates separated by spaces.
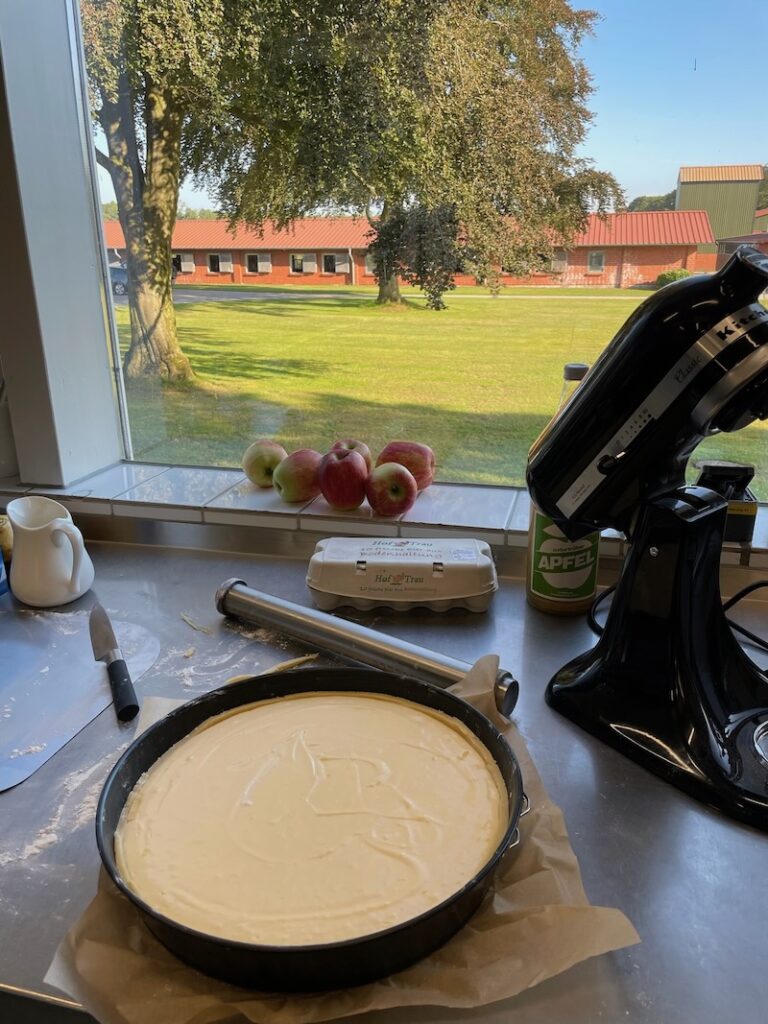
xmin=525 ymin=362 xmax=600 ymax=615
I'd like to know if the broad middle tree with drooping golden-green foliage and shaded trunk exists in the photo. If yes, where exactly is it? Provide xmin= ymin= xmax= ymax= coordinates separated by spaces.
xmin=214 ymin=0 xmax=623 ymax=301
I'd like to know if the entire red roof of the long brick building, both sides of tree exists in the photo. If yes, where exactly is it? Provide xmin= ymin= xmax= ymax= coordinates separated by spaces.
xmin=104 ymin=210 xmax=715 ymax=252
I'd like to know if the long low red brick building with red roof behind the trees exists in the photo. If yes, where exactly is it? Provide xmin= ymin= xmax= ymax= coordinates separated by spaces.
xmin=104 ymin=210 xmax=716 ymax=288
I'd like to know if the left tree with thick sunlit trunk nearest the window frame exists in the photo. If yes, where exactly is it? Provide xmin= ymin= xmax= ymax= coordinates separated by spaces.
xmin=81 ymin=0 xmax=257 ymax=380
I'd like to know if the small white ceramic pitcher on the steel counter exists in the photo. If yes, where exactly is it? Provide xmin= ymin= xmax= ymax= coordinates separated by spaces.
xmin=6 ymin=495 xmax=94 ymax=608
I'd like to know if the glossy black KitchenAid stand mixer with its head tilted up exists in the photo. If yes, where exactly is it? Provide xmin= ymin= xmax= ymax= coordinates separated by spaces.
xmin=527 ymin=246 xmax=768 ymax=829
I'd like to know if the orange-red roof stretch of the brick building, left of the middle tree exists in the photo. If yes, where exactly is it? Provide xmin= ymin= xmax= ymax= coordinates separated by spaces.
xmin=104 ymin=217 xmax=371 ymax=252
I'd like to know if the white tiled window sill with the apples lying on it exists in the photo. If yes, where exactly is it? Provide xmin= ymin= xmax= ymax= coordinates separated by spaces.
xmin=0 ymin=463 xmax=768 ymax=569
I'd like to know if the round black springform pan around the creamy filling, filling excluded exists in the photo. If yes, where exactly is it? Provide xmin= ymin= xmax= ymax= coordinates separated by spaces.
xmin=96 ymin=669 xmax=525 ymax=991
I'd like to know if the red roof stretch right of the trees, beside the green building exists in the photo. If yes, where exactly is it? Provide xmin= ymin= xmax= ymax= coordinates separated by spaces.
xmin=573 ymin=210 xmax=715 ymax=247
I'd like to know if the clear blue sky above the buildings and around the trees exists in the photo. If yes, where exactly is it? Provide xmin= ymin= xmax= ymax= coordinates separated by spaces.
xmin=99 ymin=0 xmax=768 ymax=207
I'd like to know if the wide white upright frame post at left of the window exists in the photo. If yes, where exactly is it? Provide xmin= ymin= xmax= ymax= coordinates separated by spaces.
xmin=0 ymin=0 xmax=128 ymax=486
